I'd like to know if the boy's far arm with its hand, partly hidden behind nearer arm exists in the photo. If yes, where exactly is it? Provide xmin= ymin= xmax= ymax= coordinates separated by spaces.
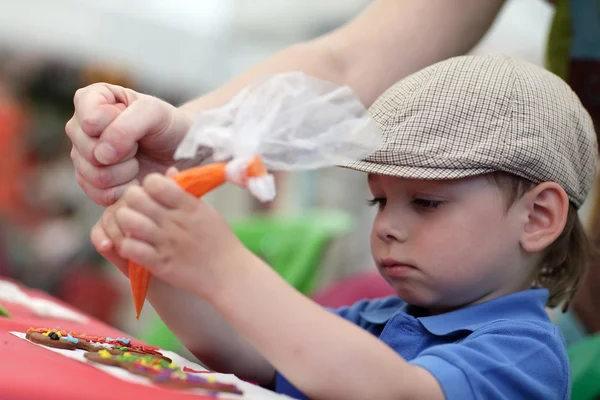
xmin=91 ymin=197 xmax=275 ymax=385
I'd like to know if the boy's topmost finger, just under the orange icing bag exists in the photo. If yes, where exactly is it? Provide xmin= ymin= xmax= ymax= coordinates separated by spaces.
xmin=142 ymin=174 xmax=196 ymax=210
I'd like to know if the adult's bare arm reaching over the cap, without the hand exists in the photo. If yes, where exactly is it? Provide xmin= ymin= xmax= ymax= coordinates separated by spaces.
xmin=181 ymin=0 xmax=504 ymax=115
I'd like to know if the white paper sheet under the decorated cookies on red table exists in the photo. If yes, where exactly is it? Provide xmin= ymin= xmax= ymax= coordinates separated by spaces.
xmin=10 ymin=332 xmax=290 ymax=400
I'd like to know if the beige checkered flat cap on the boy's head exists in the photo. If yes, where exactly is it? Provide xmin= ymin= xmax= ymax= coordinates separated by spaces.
xmin=345 ymin=56 xmax=597 ymax=207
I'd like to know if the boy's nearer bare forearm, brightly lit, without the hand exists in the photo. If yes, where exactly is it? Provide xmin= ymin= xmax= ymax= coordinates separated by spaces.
xmin=211 ymin=261 xmax=441 ymax=399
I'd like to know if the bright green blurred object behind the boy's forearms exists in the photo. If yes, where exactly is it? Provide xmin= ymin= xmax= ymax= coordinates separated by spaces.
xmin=140 ymin=210 xmax=354 ymax=351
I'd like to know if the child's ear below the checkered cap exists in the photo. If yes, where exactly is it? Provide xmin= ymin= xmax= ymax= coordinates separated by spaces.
xmin=520 ymin=182 xmax=569 ymax=253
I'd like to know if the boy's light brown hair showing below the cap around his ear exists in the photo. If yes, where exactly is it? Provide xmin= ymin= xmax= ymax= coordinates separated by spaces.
xmin=489 ymin=172 xmax=593 ymax=312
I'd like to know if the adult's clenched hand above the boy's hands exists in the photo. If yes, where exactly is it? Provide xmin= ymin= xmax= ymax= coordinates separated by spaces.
xmin=65 ymin=83 xmax=192 ymax=206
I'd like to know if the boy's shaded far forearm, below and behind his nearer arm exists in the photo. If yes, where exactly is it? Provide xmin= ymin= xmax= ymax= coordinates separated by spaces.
xmin=148 ymin=279 xmax=274 ymax=384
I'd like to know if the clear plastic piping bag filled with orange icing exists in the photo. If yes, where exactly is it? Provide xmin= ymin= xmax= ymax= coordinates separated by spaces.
xmin=124 ymin=72 xmax=381 ymax=318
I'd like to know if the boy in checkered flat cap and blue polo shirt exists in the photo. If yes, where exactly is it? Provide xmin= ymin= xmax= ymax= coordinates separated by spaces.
xmin=92 ymin=56 xmax=596 ymax=399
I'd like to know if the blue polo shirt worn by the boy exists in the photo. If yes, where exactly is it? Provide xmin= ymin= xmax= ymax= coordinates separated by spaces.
xmin=275 ymin=289 xmax=570 ymax=400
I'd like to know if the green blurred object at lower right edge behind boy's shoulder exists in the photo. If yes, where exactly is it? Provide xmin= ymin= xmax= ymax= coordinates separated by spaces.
xmin=568 ymin=335 xmax=600 ymax=400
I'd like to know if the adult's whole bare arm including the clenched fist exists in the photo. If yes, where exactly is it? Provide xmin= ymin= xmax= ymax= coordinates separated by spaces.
xmin=66 ymin=0 xmax=503 ymax=206
